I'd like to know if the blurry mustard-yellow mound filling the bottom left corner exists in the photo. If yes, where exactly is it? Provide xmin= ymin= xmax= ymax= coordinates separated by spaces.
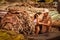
xmin=0 ymin=30 xmax=24 ymax=40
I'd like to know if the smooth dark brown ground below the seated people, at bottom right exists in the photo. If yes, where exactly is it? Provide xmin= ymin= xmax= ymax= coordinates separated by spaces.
xmin=27 ymin=32 xmax=60 ymax=40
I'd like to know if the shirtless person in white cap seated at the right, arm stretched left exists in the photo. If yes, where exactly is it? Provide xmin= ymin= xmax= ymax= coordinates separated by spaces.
xmin=38 ymin=9 xmax=52 ymax=33
